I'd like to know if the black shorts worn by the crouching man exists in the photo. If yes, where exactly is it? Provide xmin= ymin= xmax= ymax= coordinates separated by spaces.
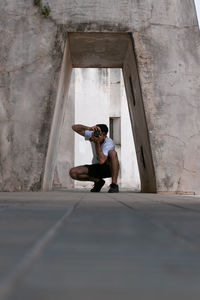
xmin=84 ymin=163 xmax=112 ymax=178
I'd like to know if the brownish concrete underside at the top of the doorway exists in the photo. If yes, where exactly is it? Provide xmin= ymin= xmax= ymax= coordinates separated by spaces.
xmin=69 ymin=33 xmax=130 ymax=68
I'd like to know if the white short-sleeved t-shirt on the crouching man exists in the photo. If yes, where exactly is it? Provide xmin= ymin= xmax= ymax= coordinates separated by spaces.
xmin=85 ymin=130 xmax=115 ymax=164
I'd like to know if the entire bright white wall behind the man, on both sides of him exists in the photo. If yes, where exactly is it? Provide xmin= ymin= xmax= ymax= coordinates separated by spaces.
xmin=75 ymin=69 xmax=140 ymax=190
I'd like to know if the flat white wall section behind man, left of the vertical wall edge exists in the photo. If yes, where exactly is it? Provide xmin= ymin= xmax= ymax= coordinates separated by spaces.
xmin=75 ymin=69 xmax=109 ymax=188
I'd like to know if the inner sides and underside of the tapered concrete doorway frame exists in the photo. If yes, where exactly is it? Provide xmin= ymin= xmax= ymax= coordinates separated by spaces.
xmin=43 ymin=33 xmax=156 ymax=192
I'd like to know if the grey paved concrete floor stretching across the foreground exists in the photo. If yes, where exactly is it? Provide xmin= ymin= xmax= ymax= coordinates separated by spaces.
xmin=0 ymin=191 xmax=200 ymax=300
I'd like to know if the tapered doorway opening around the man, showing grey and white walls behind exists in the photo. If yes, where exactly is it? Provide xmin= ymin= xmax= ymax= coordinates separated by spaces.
xmin=53 ymin=68 xmax=141 ymax=192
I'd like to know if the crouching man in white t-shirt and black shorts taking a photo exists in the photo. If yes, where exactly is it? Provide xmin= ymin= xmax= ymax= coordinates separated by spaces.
xmin=69 ymin=124 xmax=119 ymax=193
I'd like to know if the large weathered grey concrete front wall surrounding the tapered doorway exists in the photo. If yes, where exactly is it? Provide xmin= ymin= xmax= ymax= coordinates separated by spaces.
xmin=0 ymin=0 xmax=200 ymax=192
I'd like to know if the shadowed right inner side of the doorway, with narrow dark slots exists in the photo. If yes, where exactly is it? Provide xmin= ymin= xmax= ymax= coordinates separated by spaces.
xmin=123 ymin=38 xmax=156 ymax=193
